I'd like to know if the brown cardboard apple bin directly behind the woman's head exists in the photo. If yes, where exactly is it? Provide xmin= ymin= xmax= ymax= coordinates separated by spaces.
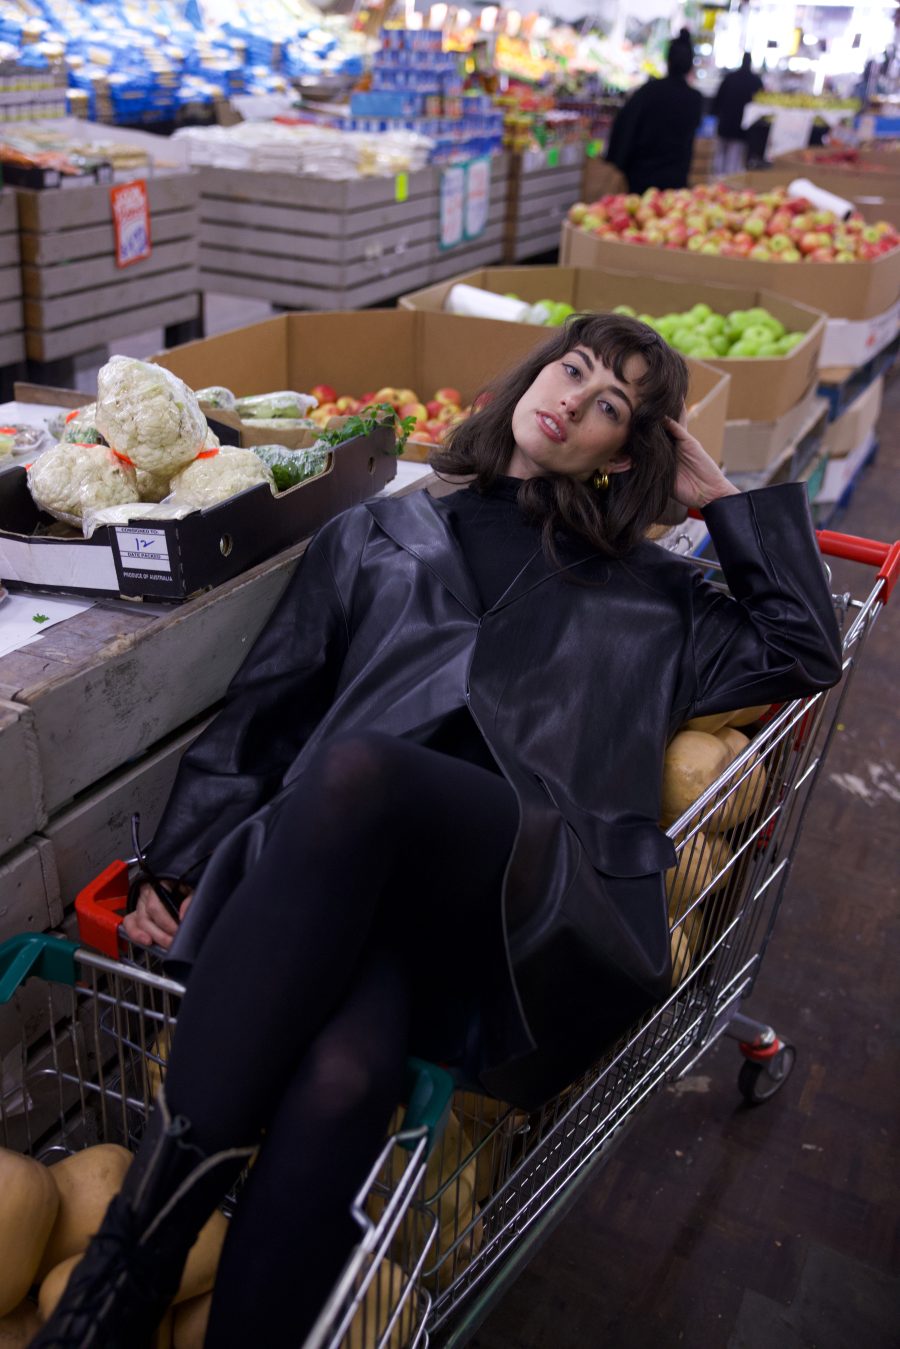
xmin=154 ymin=309 xmax=729 ymax=461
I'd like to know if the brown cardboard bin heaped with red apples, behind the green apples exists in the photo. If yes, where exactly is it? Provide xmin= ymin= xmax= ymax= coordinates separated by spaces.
xmin=560 ymin=221 xmax=900 ymax=320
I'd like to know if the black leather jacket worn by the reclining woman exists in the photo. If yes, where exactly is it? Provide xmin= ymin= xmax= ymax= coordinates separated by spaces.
xmin=148 ymin=484 xmax=841 ymax=1105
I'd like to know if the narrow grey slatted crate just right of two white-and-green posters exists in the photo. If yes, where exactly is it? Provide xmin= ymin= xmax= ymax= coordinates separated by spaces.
xmin=503 ymin=144 xmax=584 ymax=263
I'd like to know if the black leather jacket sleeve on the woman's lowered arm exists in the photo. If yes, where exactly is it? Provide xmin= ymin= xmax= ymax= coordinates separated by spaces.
xmin=147 ymin=536 xmax=348 ymax=884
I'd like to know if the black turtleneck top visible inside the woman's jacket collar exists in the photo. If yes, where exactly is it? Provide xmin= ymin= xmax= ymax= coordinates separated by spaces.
xmin=436 ymin=478 xmax=541 ymax=610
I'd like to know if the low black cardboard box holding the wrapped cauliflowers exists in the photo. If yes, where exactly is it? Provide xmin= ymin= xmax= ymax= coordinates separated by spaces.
xmin=0 ymin=386 xmax=397 ymax=600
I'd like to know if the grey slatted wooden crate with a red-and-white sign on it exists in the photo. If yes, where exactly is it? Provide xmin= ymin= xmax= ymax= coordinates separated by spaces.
xmin=16 ymin=173 xmax=200 ymax=363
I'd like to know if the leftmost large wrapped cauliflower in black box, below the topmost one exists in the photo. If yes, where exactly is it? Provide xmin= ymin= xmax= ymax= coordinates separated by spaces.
xmin=28 ymin=441 xmax=138 ymax=525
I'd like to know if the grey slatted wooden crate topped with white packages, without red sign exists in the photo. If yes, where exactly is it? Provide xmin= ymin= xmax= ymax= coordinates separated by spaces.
xmin=200 ymin=169 xmax=437 ymax=309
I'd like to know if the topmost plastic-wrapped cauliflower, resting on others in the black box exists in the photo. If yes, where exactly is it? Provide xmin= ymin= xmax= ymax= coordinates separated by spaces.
xmin=97 ymin=356 xmax=208 ymax=476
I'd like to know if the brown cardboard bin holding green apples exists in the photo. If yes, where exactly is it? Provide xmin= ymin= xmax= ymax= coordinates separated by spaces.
xmin=399 ymin=267 xmax=826 ymax=421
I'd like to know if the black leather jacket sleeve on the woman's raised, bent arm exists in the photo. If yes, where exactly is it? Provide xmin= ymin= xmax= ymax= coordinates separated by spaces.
xmin=681 ymin=483 xmax=842 ymax=719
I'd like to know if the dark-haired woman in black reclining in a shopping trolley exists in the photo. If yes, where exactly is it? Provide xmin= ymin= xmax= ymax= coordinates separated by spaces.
xmin=35 ymin=314 xmax=841 ymax=1349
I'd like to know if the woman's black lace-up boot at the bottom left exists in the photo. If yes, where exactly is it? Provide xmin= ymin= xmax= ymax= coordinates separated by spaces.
xmin=31 ymin=1091 xmax=255 ymax=1349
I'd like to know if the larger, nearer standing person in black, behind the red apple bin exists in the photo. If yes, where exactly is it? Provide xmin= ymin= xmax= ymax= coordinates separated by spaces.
xmin=606 ymin=28 xmax=703 ymax=193
